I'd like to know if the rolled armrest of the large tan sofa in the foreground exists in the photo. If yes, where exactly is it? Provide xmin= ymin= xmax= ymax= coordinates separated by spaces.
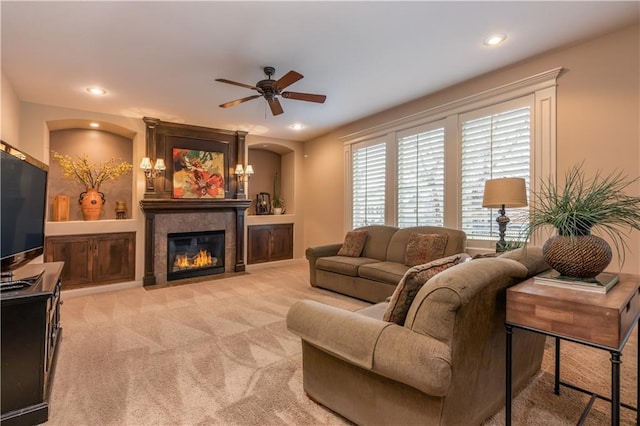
xmin=287 ymin=300 xmax=452 ymax=396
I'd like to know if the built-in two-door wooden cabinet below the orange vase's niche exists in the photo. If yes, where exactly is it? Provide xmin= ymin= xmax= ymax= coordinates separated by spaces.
xmin=44 ymin=232 xmax=136 ymax=290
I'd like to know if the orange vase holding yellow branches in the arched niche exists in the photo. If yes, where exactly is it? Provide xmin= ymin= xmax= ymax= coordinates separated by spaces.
xmin=52 ymin=151 xmax=133 ymax=220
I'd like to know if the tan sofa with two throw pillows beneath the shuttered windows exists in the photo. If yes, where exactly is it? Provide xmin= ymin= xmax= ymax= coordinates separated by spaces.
xmin=305 ymin=225 xmax=467 ymax=303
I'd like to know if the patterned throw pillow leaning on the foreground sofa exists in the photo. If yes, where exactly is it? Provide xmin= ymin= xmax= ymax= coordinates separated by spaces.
xmin=383 ymin=254 xmax=463 ymax=325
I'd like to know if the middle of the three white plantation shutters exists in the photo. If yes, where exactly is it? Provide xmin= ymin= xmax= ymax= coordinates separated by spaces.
xmin=397 ymin=127 xmax=444 ymax=228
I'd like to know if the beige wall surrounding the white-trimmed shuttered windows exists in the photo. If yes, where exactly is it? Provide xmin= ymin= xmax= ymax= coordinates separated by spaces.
xmin=303 ymin=25 xmax=640 ymax=274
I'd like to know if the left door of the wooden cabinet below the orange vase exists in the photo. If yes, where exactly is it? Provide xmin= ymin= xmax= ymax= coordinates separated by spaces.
xmin=44 ymin=235 xmax=93 ymax=288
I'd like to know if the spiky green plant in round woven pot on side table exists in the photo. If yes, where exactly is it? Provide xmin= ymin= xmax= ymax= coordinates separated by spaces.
xmin=527 ymin=164 xmax=640 ymax=279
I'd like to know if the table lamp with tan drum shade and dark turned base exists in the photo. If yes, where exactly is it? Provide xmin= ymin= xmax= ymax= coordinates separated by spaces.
xmin=482 ymin=178 xmax=527 ymax=253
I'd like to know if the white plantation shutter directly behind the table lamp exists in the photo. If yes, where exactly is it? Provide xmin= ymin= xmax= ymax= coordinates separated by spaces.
xmin=460 ymin=106 xmax=531 ymax=240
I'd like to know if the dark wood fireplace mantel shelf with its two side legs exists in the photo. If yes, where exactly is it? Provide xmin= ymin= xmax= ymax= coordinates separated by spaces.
xmin=140 ymin=198 xmax=251 ymax=286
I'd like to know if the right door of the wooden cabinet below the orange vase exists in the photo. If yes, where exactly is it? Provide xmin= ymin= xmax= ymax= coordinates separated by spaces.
xmin=93 ymin=232 xmax=136 ymax=283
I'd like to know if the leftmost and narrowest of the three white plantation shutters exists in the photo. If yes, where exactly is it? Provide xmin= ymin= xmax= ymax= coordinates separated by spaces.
xmin=351 ymin=141 xmax=387 ymax=228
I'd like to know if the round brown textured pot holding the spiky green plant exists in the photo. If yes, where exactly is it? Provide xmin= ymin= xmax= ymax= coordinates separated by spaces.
xmin=542 ymin=235 xmax=612 ymax=279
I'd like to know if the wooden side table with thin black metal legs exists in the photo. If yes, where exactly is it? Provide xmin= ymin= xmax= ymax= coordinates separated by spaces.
xmin=505 ymin=274 xmax=640 ymax=426
